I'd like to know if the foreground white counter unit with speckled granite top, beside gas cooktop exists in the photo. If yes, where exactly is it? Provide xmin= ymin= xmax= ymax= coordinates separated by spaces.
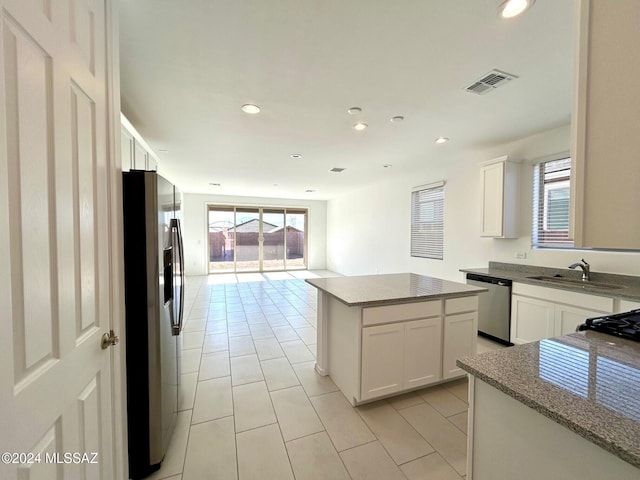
xmin=458 ymin=331 xmax=640 ymax=480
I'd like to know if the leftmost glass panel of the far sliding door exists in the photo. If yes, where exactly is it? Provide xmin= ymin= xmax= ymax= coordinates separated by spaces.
xmin=208 ymin=207 xmax=235 ymax=273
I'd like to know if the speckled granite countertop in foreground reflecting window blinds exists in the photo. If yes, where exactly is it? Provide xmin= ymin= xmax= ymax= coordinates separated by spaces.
xmin=457 ymin=331 xmax=640 ymax=468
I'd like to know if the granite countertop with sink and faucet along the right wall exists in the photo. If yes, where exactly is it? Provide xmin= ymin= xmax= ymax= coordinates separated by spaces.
xmin=460 ymin=262 xmax=640 ymax=301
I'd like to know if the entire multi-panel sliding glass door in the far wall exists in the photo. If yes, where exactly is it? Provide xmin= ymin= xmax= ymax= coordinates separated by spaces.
xmin=208 ymin=205 xmax=307 ymax=273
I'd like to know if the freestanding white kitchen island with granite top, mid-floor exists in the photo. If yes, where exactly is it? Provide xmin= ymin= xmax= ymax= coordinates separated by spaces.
xmin=306 ymin=273 xmax=486 ymax=405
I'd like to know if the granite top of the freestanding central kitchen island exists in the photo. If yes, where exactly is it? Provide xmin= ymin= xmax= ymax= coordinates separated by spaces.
xmin=306 ymin=273 xmax=487 ymax=306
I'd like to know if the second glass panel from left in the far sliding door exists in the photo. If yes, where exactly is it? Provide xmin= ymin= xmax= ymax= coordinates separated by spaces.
xmin=235 ymin=208 xmax=261 ymax=272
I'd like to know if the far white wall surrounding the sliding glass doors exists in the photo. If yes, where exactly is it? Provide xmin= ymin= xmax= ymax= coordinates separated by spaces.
xmin=183 ymin=193 xmax=327 ymax=275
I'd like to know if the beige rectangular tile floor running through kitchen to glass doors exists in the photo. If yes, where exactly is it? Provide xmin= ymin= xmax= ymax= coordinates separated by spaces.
xmin=145 ymin=272 xmax=504 ymax=480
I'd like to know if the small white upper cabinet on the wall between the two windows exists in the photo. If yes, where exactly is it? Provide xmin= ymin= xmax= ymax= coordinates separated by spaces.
xmin=480 ymin=156 xmax=520 ymax=238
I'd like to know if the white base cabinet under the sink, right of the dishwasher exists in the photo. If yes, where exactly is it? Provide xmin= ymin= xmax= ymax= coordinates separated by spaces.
xmin=511 ymin=283 xmax=614 ymax=344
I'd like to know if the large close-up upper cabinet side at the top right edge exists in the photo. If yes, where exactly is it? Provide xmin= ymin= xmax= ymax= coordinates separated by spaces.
xmin=572 ymin=0 xmax=640 ymax=249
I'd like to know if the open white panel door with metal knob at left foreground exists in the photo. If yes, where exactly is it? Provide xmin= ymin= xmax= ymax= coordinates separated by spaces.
xmin=0 ymin=0 xmax=122 ymax=480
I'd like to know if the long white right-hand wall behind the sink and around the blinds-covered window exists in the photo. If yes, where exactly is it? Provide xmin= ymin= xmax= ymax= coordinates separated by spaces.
xmin=327 ymin=125 xmax=640 ymax=281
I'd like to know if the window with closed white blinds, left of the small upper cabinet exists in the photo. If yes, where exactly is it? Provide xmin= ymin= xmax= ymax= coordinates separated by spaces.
xmin=411 ymin=182 xmax=444 ymax=260
